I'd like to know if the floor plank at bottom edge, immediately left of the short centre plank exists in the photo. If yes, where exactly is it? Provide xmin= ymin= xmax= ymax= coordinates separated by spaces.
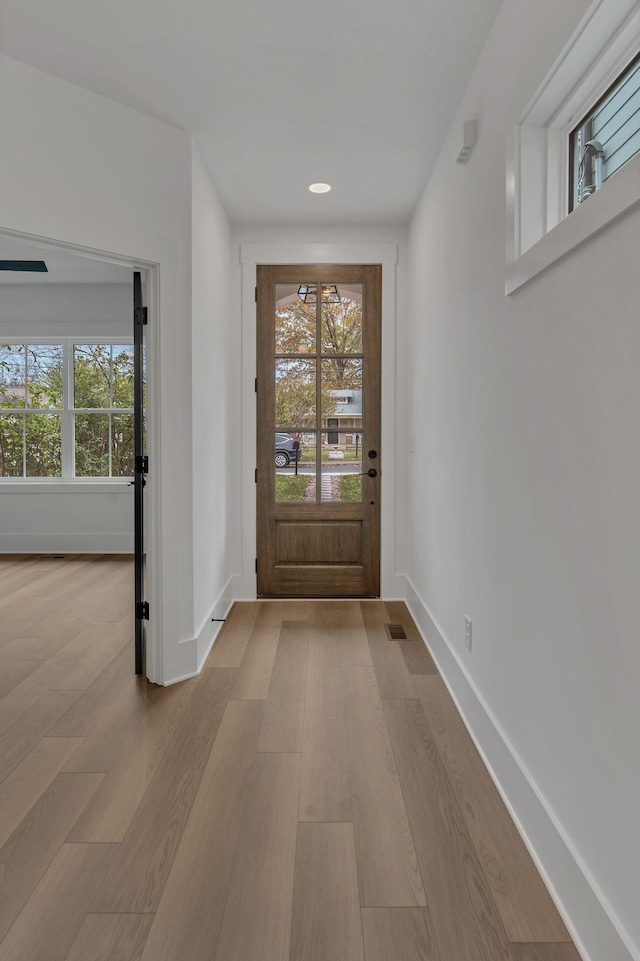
xmin=215 ymin=754 xmax=300 ymax=961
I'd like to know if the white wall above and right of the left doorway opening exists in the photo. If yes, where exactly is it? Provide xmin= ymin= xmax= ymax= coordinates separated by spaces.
xmin=0 ymin=57 xmax=198 ymax=682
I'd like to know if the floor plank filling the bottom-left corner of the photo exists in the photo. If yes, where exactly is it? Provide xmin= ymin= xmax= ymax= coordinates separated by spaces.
xmin=0 ymin=840 xmax=114 ymax=961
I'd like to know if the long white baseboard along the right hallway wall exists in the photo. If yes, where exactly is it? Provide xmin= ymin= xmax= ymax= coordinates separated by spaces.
xmin=406 ymin=577 xmax=640 ymax=961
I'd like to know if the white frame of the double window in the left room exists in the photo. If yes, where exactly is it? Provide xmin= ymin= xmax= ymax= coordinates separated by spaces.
xmin=0 ymin=334 xmax=133 ymax=489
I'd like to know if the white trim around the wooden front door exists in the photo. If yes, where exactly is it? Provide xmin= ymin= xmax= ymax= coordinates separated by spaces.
xmin=238 ymin=243 xmax=402 ymax=599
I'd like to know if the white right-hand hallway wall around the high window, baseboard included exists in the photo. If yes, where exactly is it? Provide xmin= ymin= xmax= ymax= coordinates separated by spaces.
xmin=407 ymin=0 xmax=640 ymax=961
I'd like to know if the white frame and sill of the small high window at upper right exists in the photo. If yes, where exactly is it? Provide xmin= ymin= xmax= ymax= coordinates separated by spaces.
xmin=505 ymin=0 xmax=640 ymax=295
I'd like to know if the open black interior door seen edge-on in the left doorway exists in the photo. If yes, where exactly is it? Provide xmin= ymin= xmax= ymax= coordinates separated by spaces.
xmin=133 ymin=271 xmax=149 ymax=674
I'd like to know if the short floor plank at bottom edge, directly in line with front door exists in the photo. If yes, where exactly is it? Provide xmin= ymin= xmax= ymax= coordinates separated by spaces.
xmin=290 ymin=824 xmax=364 ymax=961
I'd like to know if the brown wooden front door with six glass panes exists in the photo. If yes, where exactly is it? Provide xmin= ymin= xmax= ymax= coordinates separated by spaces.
xmin=256 ymin=264 xmax=382 ymax=597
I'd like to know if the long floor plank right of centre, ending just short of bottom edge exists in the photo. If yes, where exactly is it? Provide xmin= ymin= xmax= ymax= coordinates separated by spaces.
xmin=342 ymin=667 xmax=426 ymax=907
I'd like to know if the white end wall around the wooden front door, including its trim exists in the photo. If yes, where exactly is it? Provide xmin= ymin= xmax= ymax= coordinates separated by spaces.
xmin=231 ymin=225 xmax=407 ymax=598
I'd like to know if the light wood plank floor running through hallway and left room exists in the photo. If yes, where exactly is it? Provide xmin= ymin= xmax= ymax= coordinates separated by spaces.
xmin=0 ymin=556 xmax=579 ymax=961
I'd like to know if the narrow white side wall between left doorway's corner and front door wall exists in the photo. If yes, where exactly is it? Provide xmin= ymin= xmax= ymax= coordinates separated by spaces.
xmin=191 ymin=143 xmax=240 ymax=663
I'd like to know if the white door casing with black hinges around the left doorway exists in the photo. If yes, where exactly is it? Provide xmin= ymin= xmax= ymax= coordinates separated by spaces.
xmin=0 ymin=228 xmax=163 ymax=683
